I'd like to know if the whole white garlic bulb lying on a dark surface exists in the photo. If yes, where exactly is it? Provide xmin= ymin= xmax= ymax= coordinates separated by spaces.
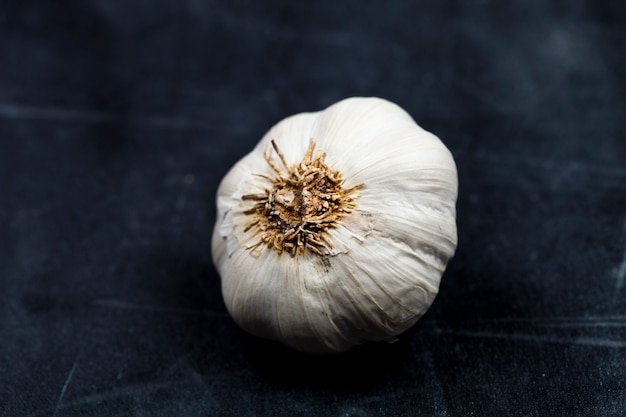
xmin=212 ymin=98 xmax=457 ymax=353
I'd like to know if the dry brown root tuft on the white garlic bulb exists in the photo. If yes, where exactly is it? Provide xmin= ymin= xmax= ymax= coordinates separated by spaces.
xmin=241 ymin=139 xmax=363 ymax=256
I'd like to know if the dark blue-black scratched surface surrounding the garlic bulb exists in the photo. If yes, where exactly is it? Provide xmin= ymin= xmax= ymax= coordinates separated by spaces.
xmin=0 ymin=0 xmax=626 ymax=417
